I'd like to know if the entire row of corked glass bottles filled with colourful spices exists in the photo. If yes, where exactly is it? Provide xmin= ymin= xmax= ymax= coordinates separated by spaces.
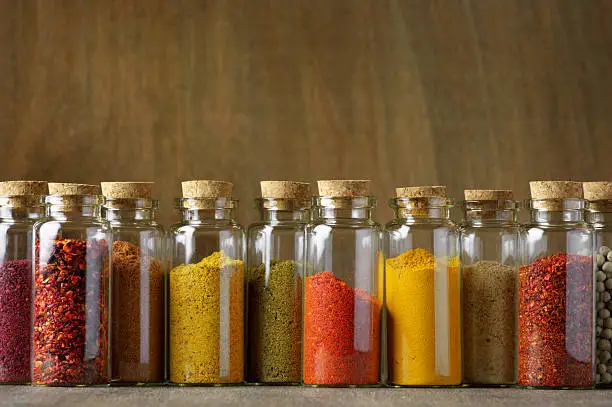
xmin=0 ymin=181 xmax=612 ymax=387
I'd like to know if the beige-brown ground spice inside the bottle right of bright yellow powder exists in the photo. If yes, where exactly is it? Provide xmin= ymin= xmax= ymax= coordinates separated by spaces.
xmin=463 ymin=260 xmax=517 ymax=384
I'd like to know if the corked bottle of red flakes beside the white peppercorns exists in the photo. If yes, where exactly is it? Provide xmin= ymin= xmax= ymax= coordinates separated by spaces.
xmin=518 ymin=181 xmax=594 ymax=388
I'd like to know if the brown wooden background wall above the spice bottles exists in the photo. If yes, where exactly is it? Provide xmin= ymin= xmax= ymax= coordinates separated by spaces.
xmin=0 ymin=0 xmax=612 ymax=223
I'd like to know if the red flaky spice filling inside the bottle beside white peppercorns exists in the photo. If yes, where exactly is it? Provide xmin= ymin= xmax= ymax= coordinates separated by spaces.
xmin=518 ymin=253 xmax=593 ymax=387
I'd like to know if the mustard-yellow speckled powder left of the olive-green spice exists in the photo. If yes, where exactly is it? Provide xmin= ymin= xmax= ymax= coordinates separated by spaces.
xmin=169 ymin=252 xmax=244 ymax=383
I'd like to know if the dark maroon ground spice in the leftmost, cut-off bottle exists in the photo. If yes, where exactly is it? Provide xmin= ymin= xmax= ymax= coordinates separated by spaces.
xmin=0 ymin=259 xmax=32 ymax=383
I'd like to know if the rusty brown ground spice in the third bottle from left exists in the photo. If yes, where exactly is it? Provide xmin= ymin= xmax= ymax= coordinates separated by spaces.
xmin=112 ymin=241 xmax=164 ymax=383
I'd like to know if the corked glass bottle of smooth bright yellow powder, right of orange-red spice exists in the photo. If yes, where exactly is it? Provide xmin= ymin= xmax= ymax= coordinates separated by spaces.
xmin=385 ymin=186 xmax=461 ymax=386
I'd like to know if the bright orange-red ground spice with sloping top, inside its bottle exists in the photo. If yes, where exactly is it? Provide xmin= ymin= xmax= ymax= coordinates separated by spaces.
xmin=304 ymin=271 xmax=381 ymax=385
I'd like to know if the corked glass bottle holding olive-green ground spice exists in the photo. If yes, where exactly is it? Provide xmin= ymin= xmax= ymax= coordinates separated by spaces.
xmin=247 ymin=181 xmax=310 ymax=384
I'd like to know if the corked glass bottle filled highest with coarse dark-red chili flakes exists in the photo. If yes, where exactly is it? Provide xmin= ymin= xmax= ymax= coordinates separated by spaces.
xmin=32 ymin=183 xmax=111 ymax=386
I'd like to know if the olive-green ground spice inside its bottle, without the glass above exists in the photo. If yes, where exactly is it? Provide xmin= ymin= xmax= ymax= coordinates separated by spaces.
xmin=247 ymin=260 xmax=302 ymax=383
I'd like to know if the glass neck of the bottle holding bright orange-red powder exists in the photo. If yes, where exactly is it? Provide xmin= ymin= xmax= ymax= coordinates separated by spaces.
xmin=313 ymin=196 xmax=376 ymax=221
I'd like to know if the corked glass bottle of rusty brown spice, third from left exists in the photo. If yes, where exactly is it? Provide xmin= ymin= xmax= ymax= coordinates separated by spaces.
xmin=102 ymin=182 xmax=165 ymax=384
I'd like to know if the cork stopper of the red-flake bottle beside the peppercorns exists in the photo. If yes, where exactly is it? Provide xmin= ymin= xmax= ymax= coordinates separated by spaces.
xmin=529 ymin=181 xmax=582 ymax=211
